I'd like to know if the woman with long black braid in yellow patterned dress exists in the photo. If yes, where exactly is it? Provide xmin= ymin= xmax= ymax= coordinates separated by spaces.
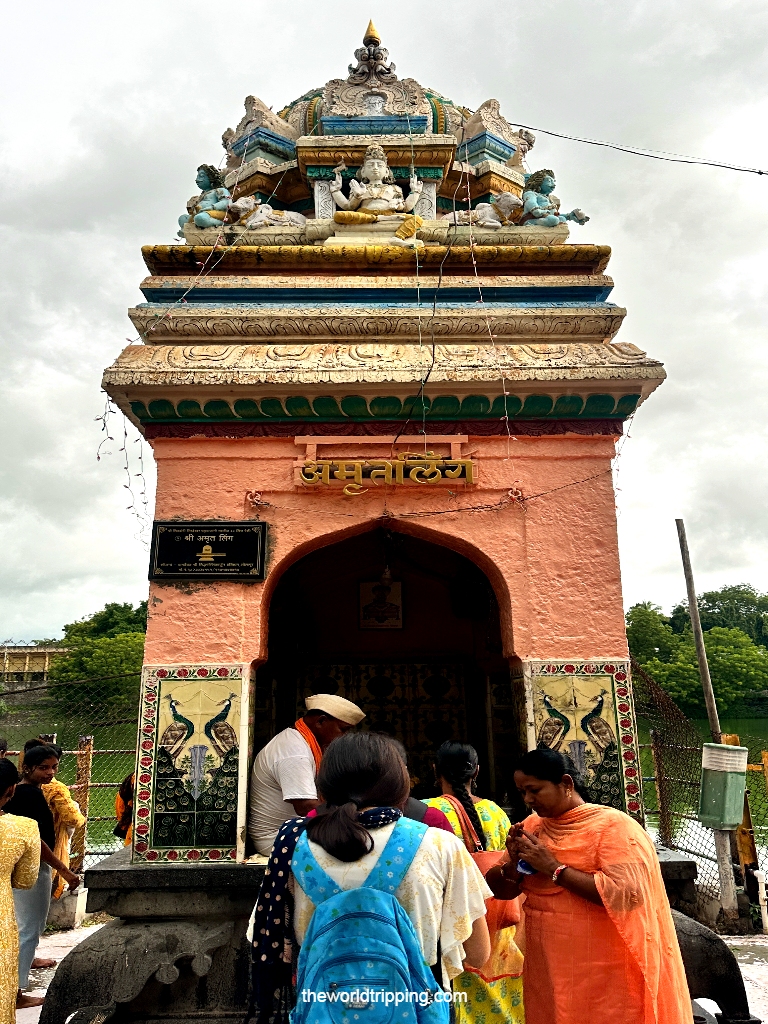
xmin=425 ymin=740 xmax=525 ymax=1024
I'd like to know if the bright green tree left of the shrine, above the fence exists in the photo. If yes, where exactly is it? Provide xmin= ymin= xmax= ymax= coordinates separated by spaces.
xmin=50 ymin=632 xmax=144 ymax=705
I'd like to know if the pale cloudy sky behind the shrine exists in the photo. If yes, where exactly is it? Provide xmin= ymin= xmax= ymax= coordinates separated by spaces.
xmin=0 ymin=0 xmax=768 ymax=641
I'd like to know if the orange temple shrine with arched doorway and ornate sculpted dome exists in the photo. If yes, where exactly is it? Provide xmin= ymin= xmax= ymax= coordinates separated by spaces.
xmin=103 ymin=26 xmax=665 ymax=864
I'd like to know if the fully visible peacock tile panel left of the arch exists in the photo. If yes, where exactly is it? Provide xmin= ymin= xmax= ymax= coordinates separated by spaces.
xmin=133 ymin=665 xmax=249 ymax=863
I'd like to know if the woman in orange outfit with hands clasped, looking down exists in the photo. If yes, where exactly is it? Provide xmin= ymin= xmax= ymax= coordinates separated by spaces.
xmin=486 ymin=750 xmax=693 ymax=1024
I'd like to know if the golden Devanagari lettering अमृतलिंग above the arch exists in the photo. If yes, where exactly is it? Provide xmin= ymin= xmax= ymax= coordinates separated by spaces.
xmin=299 ymin=452 xmax=475 ymax=495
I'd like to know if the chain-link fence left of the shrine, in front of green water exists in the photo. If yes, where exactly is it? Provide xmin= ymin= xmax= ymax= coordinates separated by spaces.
xmin=0 ymin=675 xmax=139 ymax=871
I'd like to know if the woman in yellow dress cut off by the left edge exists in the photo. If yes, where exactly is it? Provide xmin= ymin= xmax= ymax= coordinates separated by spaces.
xmin=0 ymin=758 xmax=43 ymax=1024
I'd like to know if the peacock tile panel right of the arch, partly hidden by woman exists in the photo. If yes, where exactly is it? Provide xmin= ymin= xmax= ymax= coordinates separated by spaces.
xmin=525 ymin=660 xmax=643 ymax=822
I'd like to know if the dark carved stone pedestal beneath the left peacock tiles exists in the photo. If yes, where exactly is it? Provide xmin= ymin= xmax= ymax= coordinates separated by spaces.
xmin=40 ymin=850 xmax=264 ymax=1024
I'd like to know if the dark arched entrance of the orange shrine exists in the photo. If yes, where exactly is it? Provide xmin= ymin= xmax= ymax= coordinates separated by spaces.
xmin=254 ymin=529 xmax=524 ymax=800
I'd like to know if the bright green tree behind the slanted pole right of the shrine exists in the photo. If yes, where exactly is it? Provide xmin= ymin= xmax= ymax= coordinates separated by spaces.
xmin=641 ymin=626 xmax=768 ymax=717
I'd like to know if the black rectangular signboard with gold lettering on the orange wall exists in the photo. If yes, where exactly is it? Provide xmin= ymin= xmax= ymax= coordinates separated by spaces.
xmin=150 ymin=521 xmax=266 ymax=583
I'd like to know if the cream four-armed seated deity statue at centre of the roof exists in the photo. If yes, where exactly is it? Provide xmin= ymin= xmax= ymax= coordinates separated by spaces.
xmin=331 ymin=142 xmax=424 ymax=245
